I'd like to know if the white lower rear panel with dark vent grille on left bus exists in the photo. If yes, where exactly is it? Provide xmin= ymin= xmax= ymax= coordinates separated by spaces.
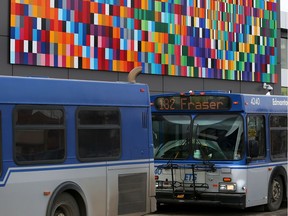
xmin=107 ymin=164 xmax=150 ymax=215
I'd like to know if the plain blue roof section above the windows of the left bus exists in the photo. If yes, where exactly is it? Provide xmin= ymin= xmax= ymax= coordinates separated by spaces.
xmin=0 ymin=76 xmax=150 ymax=106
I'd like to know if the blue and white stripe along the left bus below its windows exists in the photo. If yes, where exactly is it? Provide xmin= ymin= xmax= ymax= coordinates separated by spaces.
xmin=0 ymin=159 xmax=154 ymax=187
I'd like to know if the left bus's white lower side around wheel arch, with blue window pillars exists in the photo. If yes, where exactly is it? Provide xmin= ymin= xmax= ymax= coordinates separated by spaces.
xmin=0 ymin=105 xmax=107 ymax=216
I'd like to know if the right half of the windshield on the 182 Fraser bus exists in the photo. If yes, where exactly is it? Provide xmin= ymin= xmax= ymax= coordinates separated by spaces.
xmin=193 ymin=114 xmax=244 ymax=160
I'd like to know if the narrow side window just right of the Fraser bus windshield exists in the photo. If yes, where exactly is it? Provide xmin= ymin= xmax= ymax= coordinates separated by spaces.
xmin=247 ymin=115 xmax=266 ymax=159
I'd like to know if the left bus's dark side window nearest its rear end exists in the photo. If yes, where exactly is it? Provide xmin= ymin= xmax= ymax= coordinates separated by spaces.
xmin=77 ymin=107 xmax=121 ymax=161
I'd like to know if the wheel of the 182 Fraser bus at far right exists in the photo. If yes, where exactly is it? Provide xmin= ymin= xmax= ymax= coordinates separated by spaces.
xmin=265 ymin=176 xmax=284 ymax=211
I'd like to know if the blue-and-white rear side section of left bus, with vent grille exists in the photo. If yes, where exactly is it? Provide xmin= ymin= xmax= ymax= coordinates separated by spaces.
xmin=107 ymin=107 xmax=153 ymax=215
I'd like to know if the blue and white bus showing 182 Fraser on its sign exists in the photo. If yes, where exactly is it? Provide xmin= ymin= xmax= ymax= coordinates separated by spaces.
xmin=151 ymin=91 xmax=288 ymax=211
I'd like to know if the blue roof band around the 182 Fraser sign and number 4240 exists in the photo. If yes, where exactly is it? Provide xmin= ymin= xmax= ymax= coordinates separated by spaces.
xmin=151 ymin=91 xmax=288 ymax=113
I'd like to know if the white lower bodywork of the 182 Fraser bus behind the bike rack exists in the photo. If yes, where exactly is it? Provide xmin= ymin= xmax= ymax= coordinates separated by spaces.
xmin=155 ymin=163 xmax=287 ymax=208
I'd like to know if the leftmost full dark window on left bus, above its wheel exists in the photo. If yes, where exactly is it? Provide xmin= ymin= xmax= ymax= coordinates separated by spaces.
xmin=14 ymin=106 xmax=65 ymax=164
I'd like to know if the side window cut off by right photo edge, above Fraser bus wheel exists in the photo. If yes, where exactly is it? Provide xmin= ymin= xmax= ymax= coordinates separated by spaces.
xmin=270 ymin=115 xmax=288 ymax=160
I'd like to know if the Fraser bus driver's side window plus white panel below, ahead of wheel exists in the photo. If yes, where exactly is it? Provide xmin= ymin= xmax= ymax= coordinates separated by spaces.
xmin=246 ymin=115 xmax=268 ymax=207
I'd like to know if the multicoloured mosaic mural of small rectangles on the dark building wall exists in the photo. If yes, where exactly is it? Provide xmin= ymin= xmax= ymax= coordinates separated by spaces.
xmin=10 ymin=0 xmax=278 ymax=83
